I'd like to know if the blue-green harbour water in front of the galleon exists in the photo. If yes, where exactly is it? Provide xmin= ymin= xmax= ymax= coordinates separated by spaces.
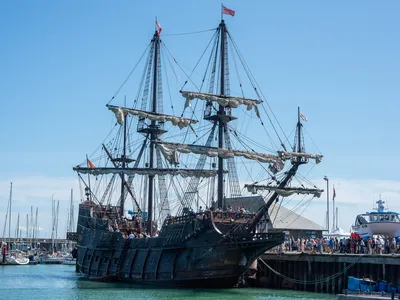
xmin=0 ymin=265 xmax=336 ymax=300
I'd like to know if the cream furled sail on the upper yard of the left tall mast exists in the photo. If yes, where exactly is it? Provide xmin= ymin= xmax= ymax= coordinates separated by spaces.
xmin=107 ymin=105 xmax=198 ymax=129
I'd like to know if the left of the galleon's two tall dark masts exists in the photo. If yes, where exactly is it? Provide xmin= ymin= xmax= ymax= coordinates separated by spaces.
xmin=147 ymin=30 xmax=160 ymax=235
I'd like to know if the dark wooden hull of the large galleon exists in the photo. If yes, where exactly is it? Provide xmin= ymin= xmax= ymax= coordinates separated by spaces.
xmin=77 ymin=223 xmax=282 ymax=288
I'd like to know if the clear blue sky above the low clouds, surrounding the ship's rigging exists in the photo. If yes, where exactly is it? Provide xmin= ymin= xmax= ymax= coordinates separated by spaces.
xmin=0 ymin=0 xmax=400 ymax=234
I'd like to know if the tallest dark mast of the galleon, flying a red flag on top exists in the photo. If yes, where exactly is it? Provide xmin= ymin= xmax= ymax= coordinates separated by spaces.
xmin=217 ymin=20 xmax=226 ymax=209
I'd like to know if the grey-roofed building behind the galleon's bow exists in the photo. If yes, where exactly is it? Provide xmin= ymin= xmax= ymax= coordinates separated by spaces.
xmin=225 ymin=196 xmax=325 ymax=238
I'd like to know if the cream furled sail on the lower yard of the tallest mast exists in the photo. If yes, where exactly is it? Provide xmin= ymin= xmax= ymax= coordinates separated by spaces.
xmin=158 ymin=142 xmax=284 ymax=172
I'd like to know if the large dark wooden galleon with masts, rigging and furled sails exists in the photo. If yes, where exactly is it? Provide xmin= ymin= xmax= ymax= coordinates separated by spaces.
xmin=69 ymin=15 xmax=322 ymax=287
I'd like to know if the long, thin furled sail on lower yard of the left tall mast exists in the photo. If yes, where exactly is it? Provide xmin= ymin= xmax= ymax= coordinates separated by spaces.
xmin=73 ymin=167 xmax=217 ymax=177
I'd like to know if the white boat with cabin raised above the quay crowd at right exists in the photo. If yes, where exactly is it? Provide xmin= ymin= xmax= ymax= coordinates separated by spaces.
xmin=352 ymin=199 xmax=400 ymax=239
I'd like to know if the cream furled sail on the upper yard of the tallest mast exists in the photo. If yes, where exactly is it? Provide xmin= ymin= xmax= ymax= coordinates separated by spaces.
xmin=181 ymin=91 xmax=262 ymax=116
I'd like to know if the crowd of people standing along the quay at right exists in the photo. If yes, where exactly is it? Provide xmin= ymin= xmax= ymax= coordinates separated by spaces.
xmin=275 ymin=235 xmax=400 ymax=254
